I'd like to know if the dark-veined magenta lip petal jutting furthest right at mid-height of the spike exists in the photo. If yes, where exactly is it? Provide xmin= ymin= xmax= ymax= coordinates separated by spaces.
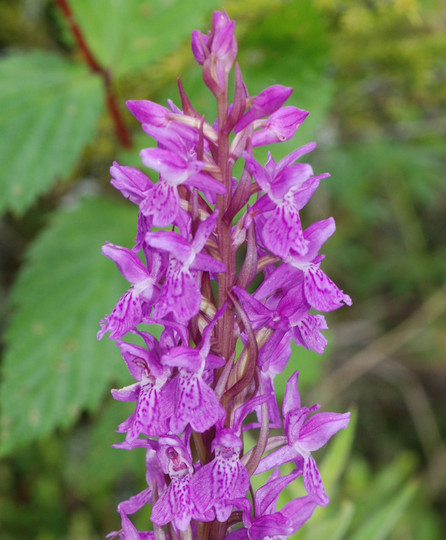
xmin=304 ymin=264 xmax=352 ymax=312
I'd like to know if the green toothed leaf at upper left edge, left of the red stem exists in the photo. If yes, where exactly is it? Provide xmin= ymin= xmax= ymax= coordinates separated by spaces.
xmin=0 ymin=52 xmax=103 ymax=213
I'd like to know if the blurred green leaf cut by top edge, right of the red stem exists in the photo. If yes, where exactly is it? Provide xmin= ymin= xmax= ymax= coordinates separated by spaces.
xmin=71 ymin=0 xmax=219 ymax=76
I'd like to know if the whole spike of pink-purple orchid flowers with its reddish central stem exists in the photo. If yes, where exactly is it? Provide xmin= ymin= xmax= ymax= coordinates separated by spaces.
xmin=98 ymin=12 xmax=351 ymax=540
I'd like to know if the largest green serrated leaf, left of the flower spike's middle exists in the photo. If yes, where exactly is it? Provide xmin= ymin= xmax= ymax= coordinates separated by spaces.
xmin=0 ymin=199 xmax=136 ymax=454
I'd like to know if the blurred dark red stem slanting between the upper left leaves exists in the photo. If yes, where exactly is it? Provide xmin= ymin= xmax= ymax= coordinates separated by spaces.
xmin=55 ymin=0 xmax=132 ymax=147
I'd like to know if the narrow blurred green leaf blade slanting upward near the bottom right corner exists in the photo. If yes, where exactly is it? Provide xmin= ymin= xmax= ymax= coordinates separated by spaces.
xmin=349 ymin=480 xmax=419 ymax=540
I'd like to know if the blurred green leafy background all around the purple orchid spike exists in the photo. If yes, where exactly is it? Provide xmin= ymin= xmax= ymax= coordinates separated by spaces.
xmin=0 ymin=0 xmax=446 ymax=540
